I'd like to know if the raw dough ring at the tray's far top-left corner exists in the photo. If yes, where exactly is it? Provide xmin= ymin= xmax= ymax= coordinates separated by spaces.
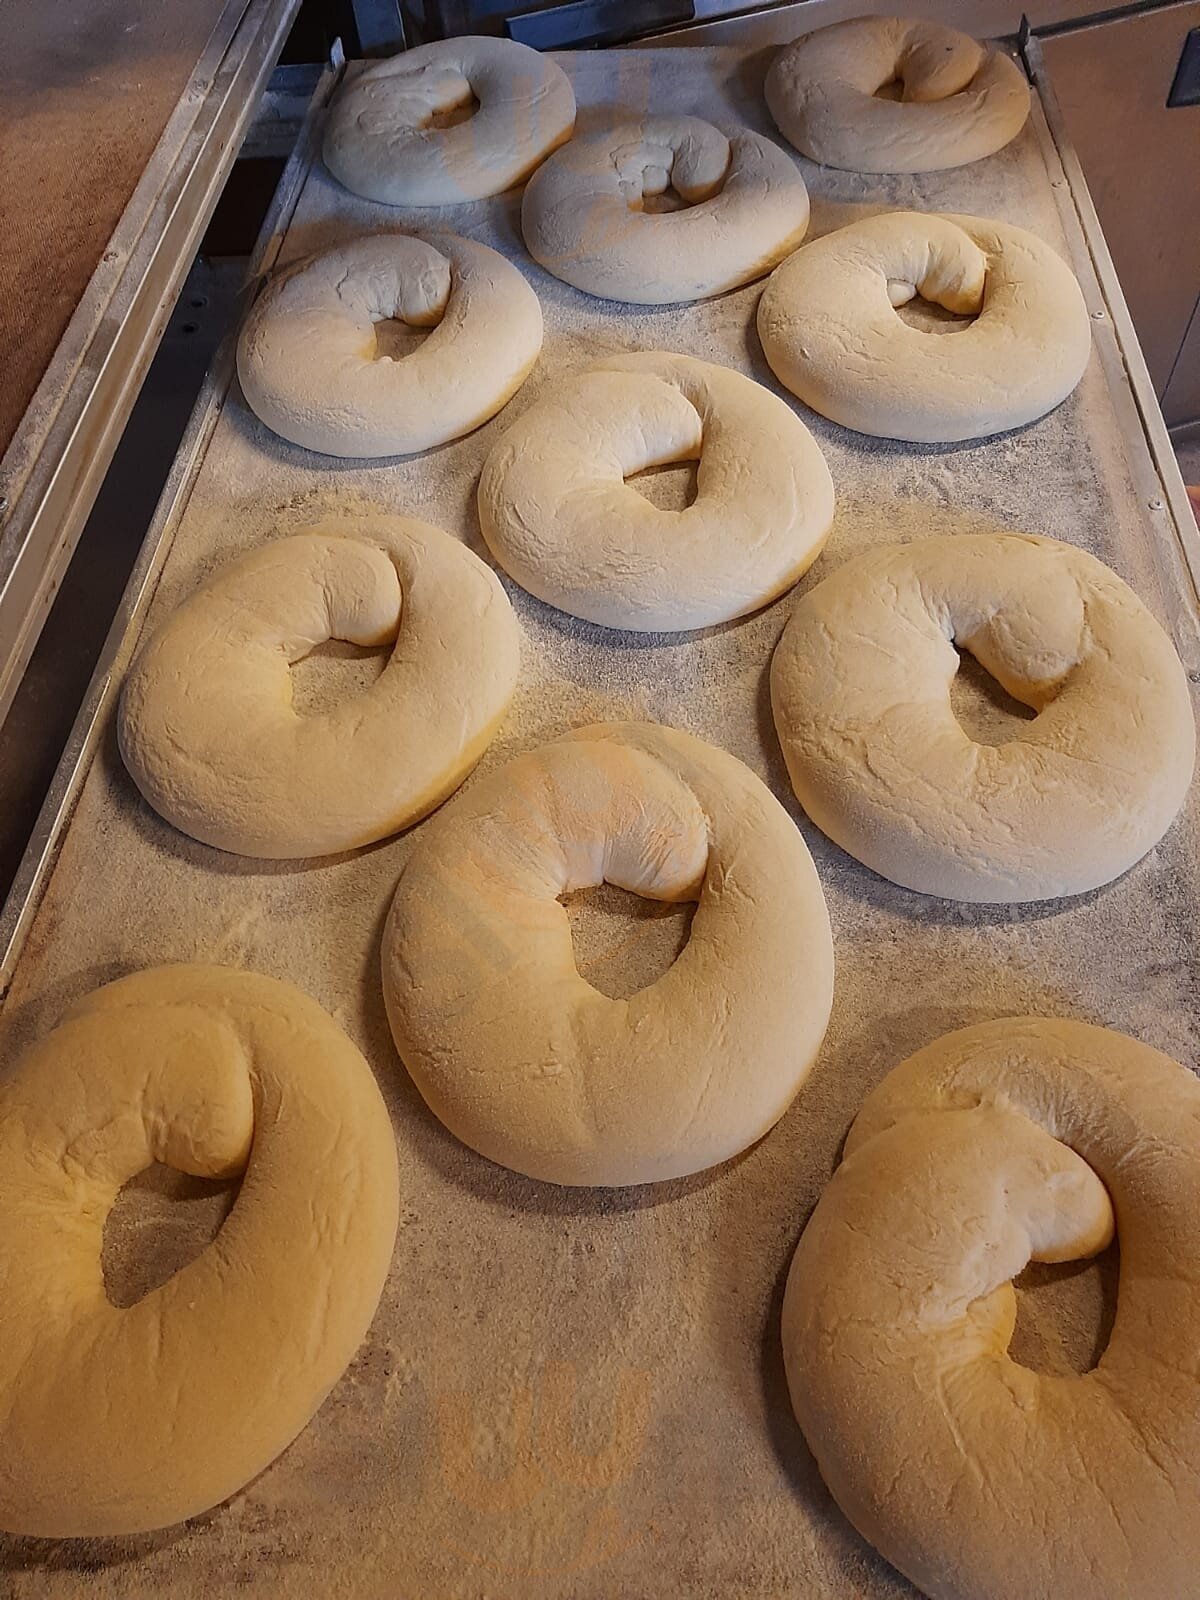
xmin=323 ymin=38 xmax=574 ymax=206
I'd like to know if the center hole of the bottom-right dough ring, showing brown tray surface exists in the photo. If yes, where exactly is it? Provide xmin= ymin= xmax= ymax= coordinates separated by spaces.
xmin=1008 ymin=1243 xmax=1120 ymax=1378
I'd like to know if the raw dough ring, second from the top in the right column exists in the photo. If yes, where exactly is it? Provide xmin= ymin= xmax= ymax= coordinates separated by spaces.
xmin=758 ymin=211 xmax=1091 ymax=445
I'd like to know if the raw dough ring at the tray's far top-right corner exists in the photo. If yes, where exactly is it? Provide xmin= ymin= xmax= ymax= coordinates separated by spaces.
xmin=763 ymin=16 xmax=1029 ymax=173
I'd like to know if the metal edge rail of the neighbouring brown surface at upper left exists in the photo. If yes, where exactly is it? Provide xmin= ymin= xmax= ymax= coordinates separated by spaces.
xmin=0 ymin=0 xmax=299 ymax=732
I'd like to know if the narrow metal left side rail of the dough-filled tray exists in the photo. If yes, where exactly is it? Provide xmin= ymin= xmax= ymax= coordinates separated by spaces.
xmin=0 ymin=68 xmax=339 ymax=1000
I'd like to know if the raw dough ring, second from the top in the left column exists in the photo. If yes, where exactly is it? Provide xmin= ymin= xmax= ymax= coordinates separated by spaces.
xmin=237 ymin=234 xmax=542 ymax=458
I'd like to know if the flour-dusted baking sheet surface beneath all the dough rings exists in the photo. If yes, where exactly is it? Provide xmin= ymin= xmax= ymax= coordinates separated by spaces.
xmin=0 ymin=50 xmax=1200 ymax=1600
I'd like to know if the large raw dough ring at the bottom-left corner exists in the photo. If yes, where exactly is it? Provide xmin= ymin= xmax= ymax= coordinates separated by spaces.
xmin=0 ymin=966 xmax=398 ymax=1539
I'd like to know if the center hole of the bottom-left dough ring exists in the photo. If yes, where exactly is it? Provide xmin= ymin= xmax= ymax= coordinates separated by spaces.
xmin=101 ymin=1162 xmax=242 ymax=1309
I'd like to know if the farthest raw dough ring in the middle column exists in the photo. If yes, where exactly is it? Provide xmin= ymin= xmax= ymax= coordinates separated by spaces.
xmin=522 ymin=117 xmax=808 ymax=306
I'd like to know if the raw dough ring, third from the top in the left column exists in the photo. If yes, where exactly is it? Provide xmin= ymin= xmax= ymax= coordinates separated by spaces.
xmin=118 ymin=517 xmax=520 ymax=859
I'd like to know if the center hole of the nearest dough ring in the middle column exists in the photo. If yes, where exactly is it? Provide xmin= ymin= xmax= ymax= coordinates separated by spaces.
xmin=562 ymin=883 xmax=696 ymax=1000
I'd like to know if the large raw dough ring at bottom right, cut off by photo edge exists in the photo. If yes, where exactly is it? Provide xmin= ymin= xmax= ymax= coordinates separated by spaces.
xmin=782 ymin=1018 xmax=1200 ymax=1600
